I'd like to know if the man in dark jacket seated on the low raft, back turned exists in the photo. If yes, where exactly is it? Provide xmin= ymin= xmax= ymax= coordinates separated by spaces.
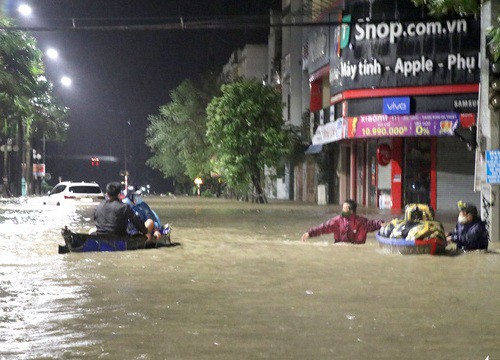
xmin=94 ymin=182 xmax=150 ymax=239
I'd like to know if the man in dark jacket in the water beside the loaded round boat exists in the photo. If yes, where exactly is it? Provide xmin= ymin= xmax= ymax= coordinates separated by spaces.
xmin=446 ymin=202 xmax=488 ymax=250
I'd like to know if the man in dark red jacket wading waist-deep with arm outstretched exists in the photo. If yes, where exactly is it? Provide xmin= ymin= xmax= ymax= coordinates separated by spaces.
xmin=301 ymin=200 xmax=383 ymax=244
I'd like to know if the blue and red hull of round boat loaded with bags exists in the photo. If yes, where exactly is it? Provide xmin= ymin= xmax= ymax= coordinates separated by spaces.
xmin=375 ymin=233 xmax=446 ymax=255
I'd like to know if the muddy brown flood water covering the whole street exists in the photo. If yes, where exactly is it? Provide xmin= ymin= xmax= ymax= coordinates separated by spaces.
xmin=0 ymin=197 xmax=500 ymax=360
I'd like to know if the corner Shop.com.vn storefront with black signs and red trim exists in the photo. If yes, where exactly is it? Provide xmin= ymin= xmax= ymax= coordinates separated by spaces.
xmin=313 ymin=0 xmax=479 ymax=210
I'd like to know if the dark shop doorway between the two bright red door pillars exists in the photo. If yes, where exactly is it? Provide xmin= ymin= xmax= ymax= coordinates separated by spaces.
xmin=403 ymin=137 xmax=431 ymax=205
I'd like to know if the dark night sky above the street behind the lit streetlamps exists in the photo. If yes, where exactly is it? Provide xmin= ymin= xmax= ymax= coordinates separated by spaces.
xmin=0 ymin=0 xmax=280 ymax=191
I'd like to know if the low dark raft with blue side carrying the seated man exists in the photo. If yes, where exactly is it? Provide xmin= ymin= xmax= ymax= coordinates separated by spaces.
xmin=59 ymin=227 xmax=175 ymax=254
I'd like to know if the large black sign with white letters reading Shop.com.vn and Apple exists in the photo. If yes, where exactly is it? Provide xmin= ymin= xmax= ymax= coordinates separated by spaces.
xmin=330 ymin=12 xmax=480 ymax=93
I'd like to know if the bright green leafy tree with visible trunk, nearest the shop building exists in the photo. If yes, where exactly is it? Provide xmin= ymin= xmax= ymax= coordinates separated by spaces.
xmin=207 ymin=80 xmax=291 ymax=203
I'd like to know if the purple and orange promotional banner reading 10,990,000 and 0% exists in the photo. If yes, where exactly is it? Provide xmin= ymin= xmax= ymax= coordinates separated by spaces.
xmin=347 ymin=113 xmax=459 ymax=138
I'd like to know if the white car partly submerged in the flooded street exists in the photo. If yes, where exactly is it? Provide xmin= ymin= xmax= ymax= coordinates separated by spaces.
xmin=44 ymin=181 xmax=104 ymax=205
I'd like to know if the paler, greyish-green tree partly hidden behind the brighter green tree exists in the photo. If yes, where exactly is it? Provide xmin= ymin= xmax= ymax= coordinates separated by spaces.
xmin=146 ymin=74 xmax=219 ymax=191
